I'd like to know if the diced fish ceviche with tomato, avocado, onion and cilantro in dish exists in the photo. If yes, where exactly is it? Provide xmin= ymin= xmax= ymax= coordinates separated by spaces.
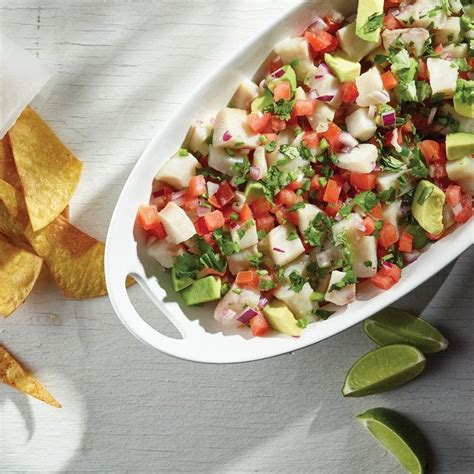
xmin=137 ymin=0 xmax=474 ymax=336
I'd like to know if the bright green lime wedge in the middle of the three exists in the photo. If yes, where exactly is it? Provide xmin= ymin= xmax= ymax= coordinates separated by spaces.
xmin=342 ymin=344 xmax=426 ymax=397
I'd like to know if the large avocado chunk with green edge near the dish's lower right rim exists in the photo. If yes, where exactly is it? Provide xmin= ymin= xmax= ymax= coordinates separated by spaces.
xmin=411 ymin=179 xmax=445 ymax=235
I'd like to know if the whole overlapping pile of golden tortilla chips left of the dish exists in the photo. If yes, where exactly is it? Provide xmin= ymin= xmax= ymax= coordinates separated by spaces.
xmin=0 ymin=108 xmax=107 ymax=317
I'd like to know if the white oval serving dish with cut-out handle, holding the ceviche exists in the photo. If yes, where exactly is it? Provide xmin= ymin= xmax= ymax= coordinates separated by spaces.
xmin=105 ymin=0 xmax=474 ymax=363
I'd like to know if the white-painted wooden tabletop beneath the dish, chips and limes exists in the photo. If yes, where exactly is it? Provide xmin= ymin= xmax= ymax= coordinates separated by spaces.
xmin=0 ymin=0 xmax=474 ymax=473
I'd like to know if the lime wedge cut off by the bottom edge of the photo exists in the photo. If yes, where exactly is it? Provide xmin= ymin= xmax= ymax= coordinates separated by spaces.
xmin=356 ymin=408 xmax=426 ymax=474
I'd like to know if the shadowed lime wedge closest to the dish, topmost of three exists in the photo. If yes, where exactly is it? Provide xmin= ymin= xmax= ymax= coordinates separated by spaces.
xmin=364 ymin=308 xmax=448 ymax=354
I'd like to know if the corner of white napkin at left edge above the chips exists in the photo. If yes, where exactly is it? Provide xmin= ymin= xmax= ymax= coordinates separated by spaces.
xmin=0 ymin=33 xmax=54 ymax=138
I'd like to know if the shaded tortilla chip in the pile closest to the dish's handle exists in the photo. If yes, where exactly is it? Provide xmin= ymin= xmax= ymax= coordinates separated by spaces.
xmin=25 ymin=216 xmax=107 ymax=299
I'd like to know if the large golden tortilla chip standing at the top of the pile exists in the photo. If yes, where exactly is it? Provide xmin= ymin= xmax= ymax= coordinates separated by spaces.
xmin=8 ymin=107 xmax=82 ymax=231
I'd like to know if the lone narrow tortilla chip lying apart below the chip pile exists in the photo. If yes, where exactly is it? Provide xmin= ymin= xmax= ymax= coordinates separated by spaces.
xmin=0 ymin=346 xmax=61 ymax=408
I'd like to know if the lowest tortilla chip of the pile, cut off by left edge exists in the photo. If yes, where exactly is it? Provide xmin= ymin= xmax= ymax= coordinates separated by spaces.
xmin=0 ymin=241 xmax=43 ymax=317
